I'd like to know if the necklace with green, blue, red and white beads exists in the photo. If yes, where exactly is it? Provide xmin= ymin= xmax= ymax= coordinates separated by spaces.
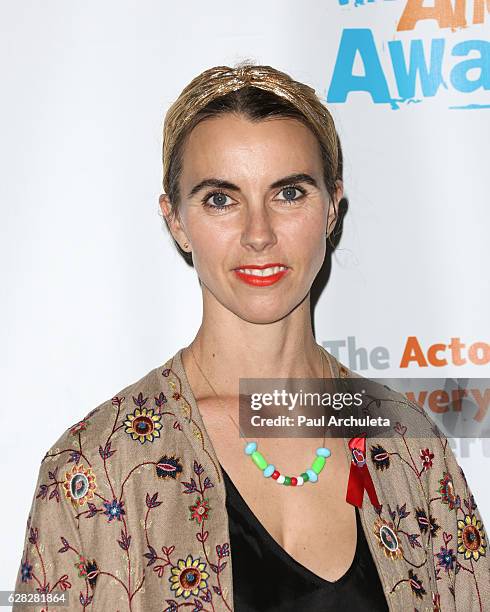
xmin=189 ymin=345 xmax=331 ymax=487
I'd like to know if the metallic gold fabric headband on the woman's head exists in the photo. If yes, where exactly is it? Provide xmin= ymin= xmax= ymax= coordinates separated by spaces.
xmin=162 ymin=65 xmax=339 ymax=193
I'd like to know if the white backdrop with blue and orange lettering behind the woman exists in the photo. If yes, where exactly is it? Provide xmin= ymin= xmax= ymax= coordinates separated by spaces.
xmin=0 ymin=0 xmax=490 ymax=589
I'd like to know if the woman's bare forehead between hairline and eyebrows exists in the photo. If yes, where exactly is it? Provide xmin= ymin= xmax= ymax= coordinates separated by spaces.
xmin=178 ymin=113 xmax=322 ymax=184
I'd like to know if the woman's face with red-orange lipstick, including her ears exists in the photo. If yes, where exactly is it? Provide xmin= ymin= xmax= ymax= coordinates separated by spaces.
xmin=160 ymin=114 xmax=342 ymax=323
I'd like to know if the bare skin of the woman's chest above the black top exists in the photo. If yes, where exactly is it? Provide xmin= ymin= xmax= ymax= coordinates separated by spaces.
xmin=199 ymin=402 xmax=357 ymax=582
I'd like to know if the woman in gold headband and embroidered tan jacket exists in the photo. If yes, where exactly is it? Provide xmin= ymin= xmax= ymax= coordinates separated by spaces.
xmin=14 ymin=64 xmax=490 ymax=611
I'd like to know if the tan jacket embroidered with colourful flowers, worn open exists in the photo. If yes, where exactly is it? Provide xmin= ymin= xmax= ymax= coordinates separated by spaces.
xmin=13 ymin=349 xmax=490 ymax=612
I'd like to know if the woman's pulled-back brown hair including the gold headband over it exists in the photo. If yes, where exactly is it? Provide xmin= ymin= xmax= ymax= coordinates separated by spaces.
xmin=162 ymin=62 xmax=343 ymax=258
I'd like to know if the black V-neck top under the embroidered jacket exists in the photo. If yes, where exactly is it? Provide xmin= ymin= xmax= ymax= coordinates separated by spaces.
xmin=221 ymin=466 xmax=388 ymax=612
